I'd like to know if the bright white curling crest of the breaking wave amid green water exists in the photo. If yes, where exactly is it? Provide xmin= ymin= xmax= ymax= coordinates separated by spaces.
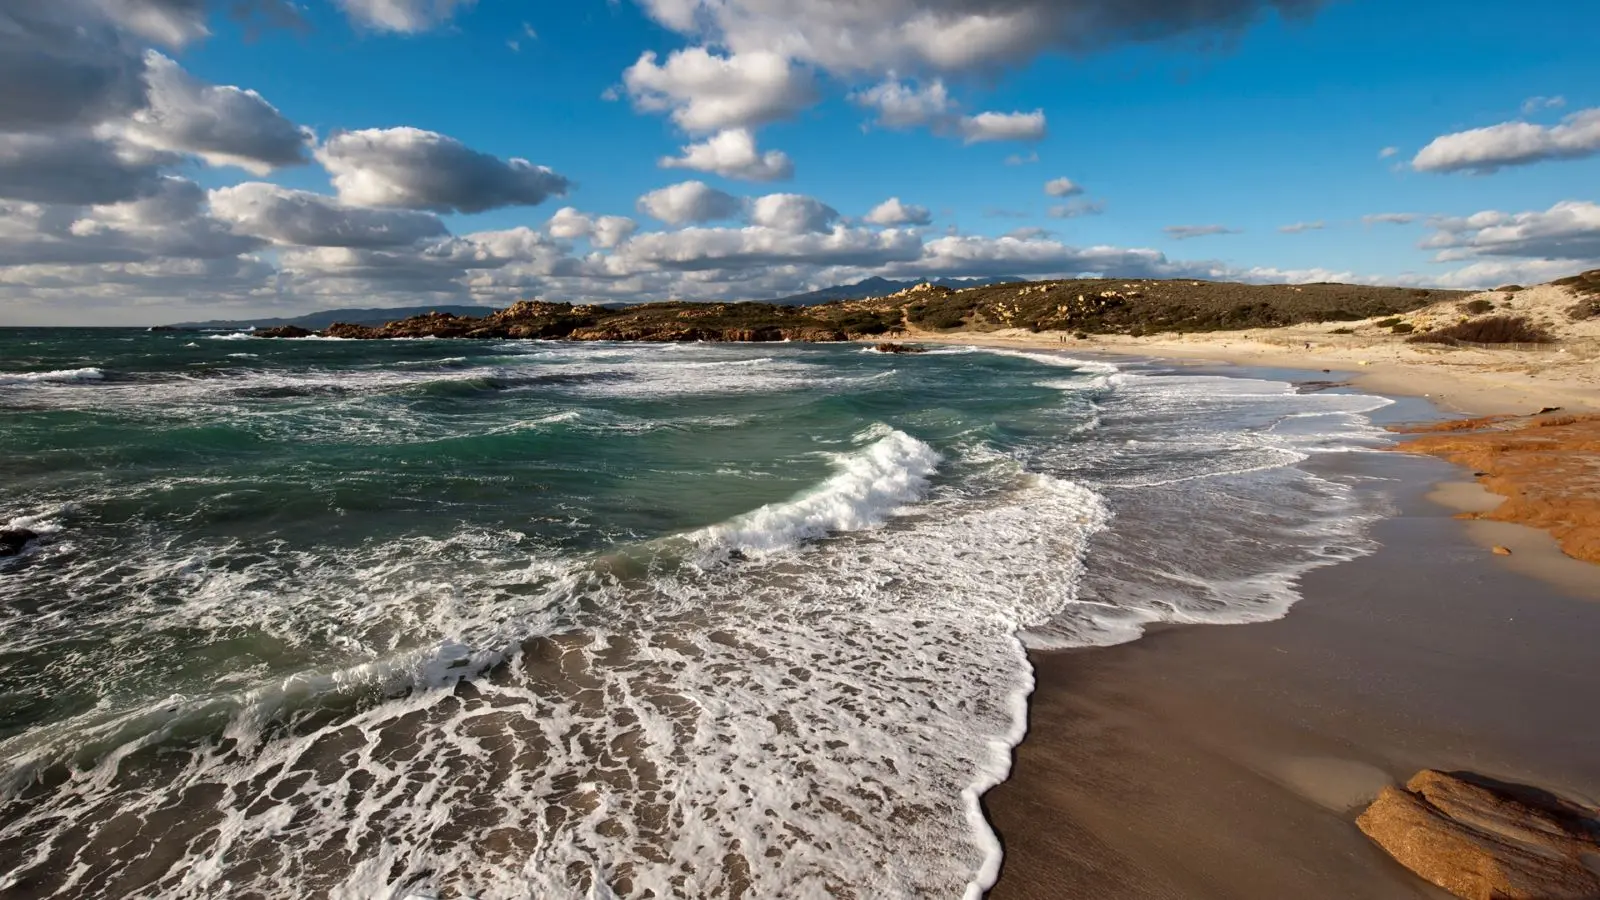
xmin=690 ymin=429 xmax=941 ymax=554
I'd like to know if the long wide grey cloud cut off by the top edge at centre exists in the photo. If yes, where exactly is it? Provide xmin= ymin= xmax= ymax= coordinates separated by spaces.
xmin=624 ymin=0 xmax=1322 ymax=74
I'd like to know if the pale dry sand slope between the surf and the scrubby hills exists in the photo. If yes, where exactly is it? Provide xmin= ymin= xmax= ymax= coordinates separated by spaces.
xmin=907 ymin=285 xmax=1600 ymax=415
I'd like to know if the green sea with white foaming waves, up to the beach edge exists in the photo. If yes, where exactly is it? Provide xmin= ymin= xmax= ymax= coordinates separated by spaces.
xmin=0 ymin=328 xmax=1389 ymax=900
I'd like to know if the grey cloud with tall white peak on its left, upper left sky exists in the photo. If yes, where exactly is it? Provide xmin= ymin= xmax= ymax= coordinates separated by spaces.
xmin=123 ymin=51 xmax=312 ymax=175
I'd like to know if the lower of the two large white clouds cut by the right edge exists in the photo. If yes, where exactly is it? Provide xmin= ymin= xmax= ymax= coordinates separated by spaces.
xmin=1422 ymin=200 xmax=1600 ymax=259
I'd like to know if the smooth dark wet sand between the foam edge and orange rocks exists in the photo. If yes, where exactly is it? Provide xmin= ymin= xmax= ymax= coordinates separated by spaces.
xmin=984 ymin=453 xmax=1600 ymax=900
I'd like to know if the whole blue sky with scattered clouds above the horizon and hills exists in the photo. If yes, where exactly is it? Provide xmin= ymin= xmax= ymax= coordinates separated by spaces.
xmin=0 ymin=0 xmax=1600 ymax=325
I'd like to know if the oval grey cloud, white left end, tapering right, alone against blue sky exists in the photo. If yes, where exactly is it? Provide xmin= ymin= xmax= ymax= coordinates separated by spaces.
xmin=317 ymin=128 xmax=571 ymax=213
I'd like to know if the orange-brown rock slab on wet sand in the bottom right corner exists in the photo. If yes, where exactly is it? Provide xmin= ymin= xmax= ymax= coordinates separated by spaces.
xmin=1357 ymin=769 xmax=1600 ymax=900
